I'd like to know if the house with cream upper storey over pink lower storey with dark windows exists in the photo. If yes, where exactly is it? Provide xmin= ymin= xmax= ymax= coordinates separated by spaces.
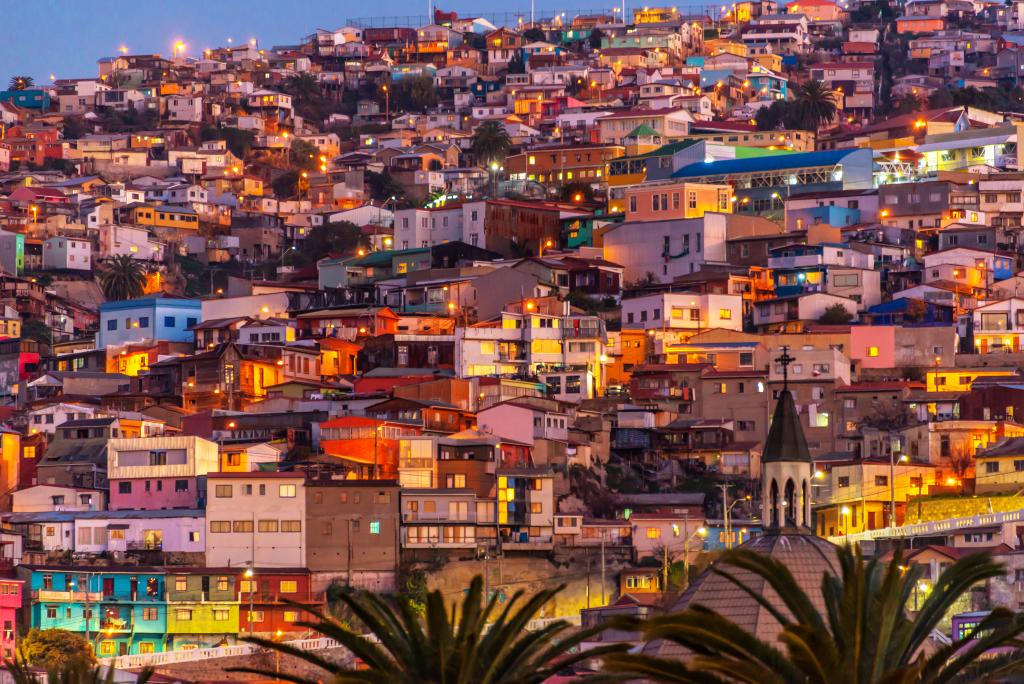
xmin=106 ymin=435 xmax=219 ymax=511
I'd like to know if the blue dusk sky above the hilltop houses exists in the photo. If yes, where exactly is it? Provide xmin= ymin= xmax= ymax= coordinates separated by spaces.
xmin=0 ymin=0 xmax=638 ymax=82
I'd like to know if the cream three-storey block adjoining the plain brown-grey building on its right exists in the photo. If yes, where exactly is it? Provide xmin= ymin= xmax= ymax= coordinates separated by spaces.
xmin=206 ymin=472 xmax=306 ymax=567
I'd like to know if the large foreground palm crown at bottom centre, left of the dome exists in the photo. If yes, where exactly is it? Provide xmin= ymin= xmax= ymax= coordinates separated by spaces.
xmin=237 ymin=575 xmax=623 ymax=684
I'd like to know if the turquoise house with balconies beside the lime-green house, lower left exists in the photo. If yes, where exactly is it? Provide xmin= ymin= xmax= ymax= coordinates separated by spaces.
xmin=31 ymin=566 xmax=167 ymax=657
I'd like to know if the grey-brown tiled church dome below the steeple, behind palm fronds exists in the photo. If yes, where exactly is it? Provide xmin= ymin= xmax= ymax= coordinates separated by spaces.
xmin=644 ymin=528 xmax=841 ymax=658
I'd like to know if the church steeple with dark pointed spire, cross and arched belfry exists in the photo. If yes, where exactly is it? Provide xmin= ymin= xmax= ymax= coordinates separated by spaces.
xmin=761 ymin=346 xmax=811 ymax=532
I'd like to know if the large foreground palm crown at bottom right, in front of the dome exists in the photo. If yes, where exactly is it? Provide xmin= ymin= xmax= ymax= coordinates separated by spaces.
xmin=605 ymin=547 xmax=1024 ymax=684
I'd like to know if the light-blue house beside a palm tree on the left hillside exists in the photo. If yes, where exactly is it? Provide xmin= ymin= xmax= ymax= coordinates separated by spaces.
xmin=96 ymin=295 xmax=202 ymax=348
